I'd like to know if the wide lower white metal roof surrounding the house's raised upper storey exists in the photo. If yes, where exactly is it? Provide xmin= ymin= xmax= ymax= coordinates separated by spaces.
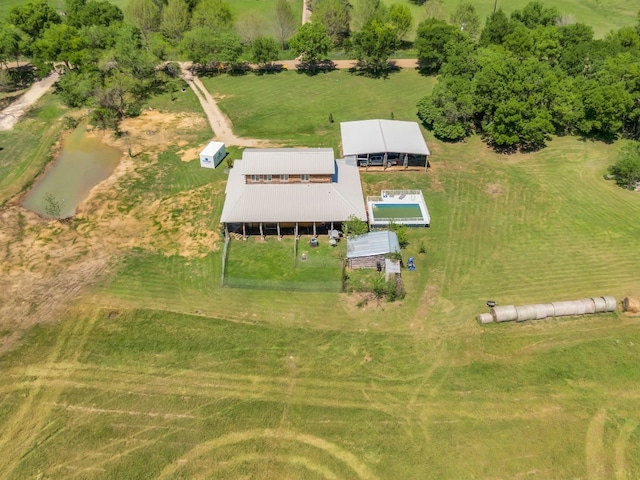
xmin=220 ymin=159 xmax=367 ymax=223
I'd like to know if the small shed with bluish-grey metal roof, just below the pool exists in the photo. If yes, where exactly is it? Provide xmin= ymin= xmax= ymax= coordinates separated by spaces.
xmin=347 ymin=230 xmax=400 ymax=268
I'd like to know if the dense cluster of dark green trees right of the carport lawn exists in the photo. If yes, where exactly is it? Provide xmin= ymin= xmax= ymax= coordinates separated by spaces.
xmin=414 ymin=1 xmax=640 ymax=151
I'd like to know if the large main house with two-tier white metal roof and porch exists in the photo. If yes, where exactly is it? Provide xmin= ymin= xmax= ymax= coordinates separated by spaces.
xmin=220 ymin=148 xmax=367 ymax=237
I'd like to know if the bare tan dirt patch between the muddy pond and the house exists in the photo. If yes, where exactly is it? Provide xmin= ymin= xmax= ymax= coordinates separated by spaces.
xmin=0 ymin=111 xmax=219 ymax=353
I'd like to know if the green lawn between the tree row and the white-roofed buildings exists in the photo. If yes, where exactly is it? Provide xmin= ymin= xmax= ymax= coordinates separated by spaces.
xmin=203 ymin=70 xmax=435 ymax=152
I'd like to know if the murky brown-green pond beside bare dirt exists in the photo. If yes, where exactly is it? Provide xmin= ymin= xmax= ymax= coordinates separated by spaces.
xmin=22 ymin=124 xmax=121 ymax=218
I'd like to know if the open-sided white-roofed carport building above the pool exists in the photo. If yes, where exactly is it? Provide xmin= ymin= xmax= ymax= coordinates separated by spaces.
xmin=340 ymin=119 xmax=431 ymax=169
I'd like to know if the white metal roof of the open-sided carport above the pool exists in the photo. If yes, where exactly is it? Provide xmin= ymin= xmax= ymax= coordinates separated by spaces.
xmin=340 ymin=120 xmax=430 ymax=157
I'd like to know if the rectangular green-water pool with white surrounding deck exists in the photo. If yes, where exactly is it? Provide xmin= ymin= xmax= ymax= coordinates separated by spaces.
xmin=367 ymin=190 xmax=431 ymax=227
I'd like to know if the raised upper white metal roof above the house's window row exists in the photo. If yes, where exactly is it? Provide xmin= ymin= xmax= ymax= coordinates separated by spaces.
xmin=236 ymin=148 xmax=336 ymax=175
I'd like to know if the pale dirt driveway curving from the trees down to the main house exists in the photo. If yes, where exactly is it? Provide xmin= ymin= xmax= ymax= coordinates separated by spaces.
xmin=180 ymin=62 xmax=272 ymax=147
